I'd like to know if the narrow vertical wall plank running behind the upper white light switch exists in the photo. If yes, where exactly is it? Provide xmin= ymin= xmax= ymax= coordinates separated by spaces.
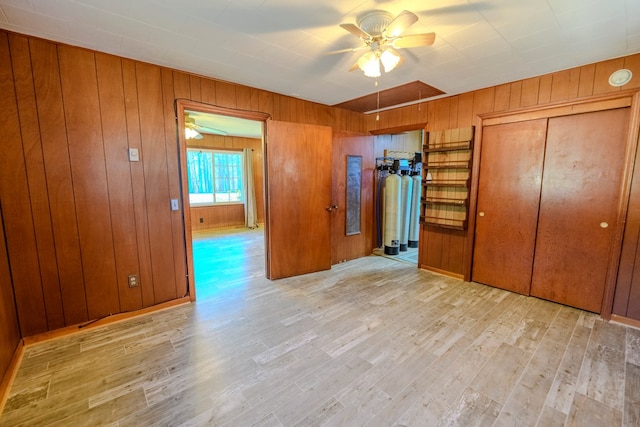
xmin=122 ymin=59 xmax=155 ymax=307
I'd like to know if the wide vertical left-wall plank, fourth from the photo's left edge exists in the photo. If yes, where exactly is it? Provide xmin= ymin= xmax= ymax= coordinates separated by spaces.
xmin=58 ymin=46 xmax=120 ymax=319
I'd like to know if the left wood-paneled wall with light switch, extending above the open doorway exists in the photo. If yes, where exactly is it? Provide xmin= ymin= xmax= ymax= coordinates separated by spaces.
xmin=0 ymin=30 xmax=365 ymax=337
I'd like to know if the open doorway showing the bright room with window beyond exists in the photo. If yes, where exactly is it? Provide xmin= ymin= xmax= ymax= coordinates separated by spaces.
xmin=177 ymin=101 xmax=266 ymax=301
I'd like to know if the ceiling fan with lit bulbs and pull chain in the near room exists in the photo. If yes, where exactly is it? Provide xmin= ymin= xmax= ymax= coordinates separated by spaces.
xmin=330 ymin=10 xmax=436 ymax=78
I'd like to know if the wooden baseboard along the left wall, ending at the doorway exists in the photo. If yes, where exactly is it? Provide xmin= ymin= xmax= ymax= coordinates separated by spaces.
xmin=23 ymin=295 xmax=191 ymax=347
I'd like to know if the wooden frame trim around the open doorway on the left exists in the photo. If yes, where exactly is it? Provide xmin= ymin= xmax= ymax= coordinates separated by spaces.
xmin=174 ymin=98 xmax=271 ymax=302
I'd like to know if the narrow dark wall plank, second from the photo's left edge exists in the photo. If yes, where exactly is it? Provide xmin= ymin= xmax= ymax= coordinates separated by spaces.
xmin=9 ymin=34 xmax=65 ymax=329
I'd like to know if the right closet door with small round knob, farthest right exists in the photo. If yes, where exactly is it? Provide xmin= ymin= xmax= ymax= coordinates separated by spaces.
xmin=531 ymin=108 xmax=629 ymax=313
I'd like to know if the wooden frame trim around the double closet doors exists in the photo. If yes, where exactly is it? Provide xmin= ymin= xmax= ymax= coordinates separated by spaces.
xmin=464 ymin=90 xmax=640 ymax=320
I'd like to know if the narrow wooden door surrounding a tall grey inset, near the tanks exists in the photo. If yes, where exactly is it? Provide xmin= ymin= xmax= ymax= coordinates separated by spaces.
xmin=331 ymin=132 xmax=375 ymax=264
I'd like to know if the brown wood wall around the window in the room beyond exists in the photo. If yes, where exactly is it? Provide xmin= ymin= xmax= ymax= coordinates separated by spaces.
xmin=187 ymin=134 xmax=264 ymax=230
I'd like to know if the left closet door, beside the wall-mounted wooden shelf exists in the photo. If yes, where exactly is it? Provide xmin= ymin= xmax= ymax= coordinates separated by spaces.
xmin=471 ymin=119 xmax=547 ymax=295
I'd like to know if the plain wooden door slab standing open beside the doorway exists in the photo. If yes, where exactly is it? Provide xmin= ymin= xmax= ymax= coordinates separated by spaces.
xmin=265 ymin=120 xmax=334 ymax=279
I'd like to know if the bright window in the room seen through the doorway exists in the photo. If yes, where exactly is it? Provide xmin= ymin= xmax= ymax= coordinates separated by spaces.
xmin=187 ymin=148 xmax=244 ymax=206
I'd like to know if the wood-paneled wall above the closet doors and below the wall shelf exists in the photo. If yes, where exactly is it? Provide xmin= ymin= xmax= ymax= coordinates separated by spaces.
xmin=367 ymin=54 xmax=640 ymax=275
